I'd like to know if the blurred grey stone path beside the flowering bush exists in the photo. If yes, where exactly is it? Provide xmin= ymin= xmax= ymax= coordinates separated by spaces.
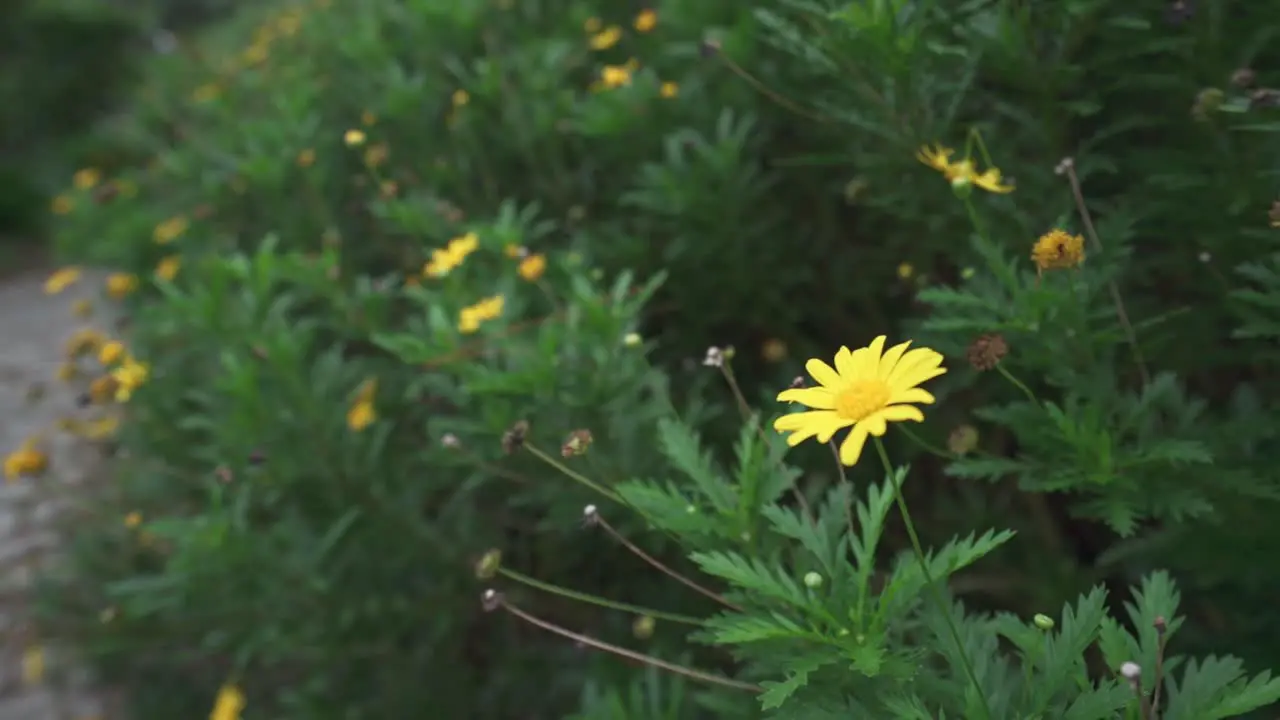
xmin=0 ymin=263 xmax=114 ymax=720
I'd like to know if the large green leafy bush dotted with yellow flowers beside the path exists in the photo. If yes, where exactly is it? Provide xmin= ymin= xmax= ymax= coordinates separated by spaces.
xmin=30 ymin=0 xmax=1280 ymax=720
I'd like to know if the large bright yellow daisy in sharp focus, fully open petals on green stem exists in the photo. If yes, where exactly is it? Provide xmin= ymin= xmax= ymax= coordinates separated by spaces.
xmin=773 ymin=336 xmax=946 ymax=466
